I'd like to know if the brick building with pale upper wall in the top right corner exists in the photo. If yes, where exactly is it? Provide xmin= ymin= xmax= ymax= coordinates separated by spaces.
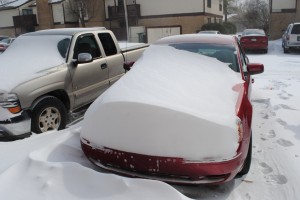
xmin=269 ymin=0 xmax=300 ymax=39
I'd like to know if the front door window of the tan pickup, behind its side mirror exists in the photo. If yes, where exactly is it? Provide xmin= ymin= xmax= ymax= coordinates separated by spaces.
xmin=73 ymin=34 xmax=101 ymax=59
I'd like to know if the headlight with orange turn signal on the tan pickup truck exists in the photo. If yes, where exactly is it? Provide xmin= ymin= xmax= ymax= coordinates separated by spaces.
xmin=0 ymin=93 xmax=21 ymax=114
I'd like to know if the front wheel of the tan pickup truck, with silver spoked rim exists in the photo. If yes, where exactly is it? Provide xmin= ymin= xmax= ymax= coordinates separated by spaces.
xmin=31 ymin=96 xmax=67 ymax=133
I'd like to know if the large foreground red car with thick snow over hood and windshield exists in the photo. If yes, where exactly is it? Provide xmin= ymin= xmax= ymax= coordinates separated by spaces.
xmin=81 ymin=34 xmax=264 ymax=184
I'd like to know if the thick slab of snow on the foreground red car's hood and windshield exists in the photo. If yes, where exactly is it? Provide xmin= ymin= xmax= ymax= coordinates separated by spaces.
xmin=81 ymin=45 xmax=243 ymax=160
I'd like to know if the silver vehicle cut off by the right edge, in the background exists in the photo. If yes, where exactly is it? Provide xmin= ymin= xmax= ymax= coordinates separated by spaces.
xmin=282 ymin=22 xmax=300 ymax=53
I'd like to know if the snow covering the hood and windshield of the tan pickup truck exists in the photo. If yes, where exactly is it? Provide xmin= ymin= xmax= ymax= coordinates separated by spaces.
xmin=0 ymin=35 xmax=70 ymax=92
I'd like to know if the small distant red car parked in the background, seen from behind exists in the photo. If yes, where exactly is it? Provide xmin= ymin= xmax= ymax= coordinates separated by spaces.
xmin=240 ymin=29 xmax=269 ymax=53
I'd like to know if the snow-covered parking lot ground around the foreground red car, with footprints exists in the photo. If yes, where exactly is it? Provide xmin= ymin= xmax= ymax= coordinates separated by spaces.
xmin=0 ymin=40 xmax=300 ymax=200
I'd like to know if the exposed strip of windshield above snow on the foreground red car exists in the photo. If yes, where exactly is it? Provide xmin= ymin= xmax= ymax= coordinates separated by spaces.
xmin=169 ymin=43 xmax=240 ymax=72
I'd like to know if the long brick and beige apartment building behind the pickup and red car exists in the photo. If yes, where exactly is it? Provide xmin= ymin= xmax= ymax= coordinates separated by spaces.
xmin=0 ymin=0 xmax=223 ymax=43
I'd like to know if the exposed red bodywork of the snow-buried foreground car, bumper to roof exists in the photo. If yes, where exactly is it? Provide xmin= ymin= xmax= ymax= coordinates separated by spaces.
xmin=81 ymin=34 xmax=263 ymax=184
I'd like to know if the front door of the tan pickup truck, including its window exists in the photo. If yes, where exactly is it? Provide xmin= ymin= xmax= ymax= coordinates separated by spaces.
xmin=71 ymin=34 xmax=109 ymax=107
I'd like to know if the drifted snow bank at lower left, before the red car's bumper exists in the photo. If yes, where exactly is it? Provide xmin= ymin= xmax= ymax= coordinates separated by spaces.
xmin=0 ymin=126 xmax=188 ymax=200
